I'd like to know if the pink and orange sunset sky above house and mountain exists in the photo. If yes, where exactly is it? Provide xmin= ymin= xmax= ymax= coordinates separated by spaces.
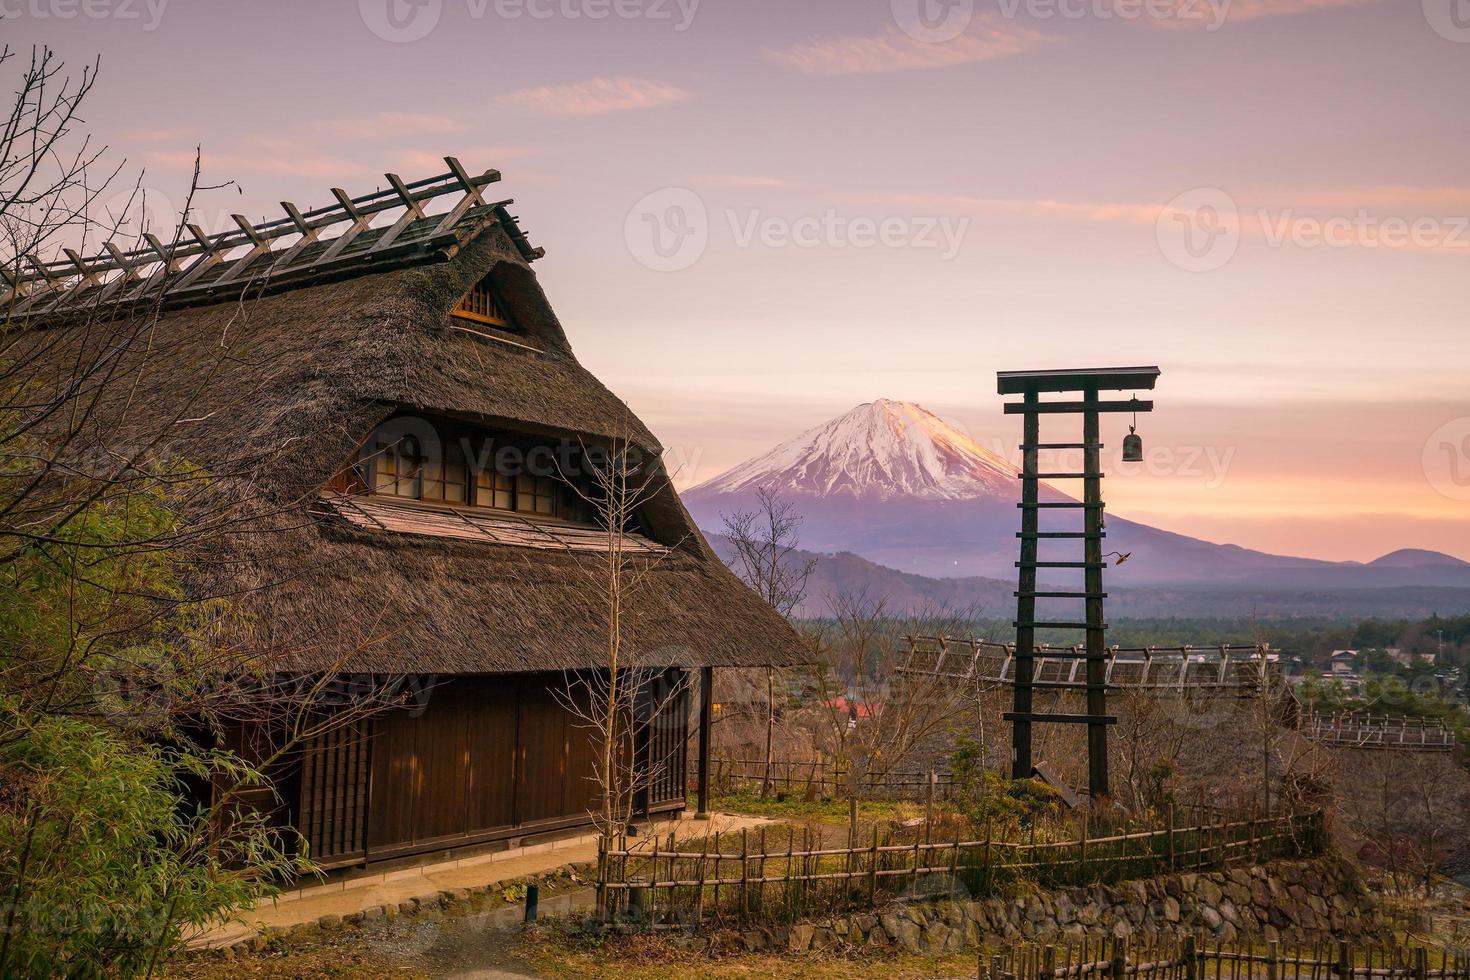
xmin=20 ymin=0 xmax=1470 ymax=560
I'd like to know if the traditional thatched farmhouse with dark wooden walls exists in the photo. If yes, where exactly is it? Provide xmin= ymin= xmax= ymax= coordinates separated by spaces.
xmin=6 ymin=159 xmax=801 ymax=868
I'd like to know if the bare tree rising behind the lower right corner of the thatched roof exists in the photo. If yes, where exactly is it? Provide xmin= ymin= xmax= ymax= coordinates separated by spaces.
xmin=722 ymin=486 xmax=817 ymax=799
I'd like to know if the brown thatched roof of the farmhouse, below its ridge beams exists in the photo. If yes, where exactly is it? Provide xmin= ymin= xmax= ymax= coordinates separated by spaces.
xmin=0 ymin=166 xmax=804 ymax=673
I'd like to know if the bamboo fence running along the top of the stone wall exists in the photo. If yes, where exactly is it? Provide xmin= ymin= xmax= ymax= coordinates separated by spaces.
xmin=597 ymin=810 xmax=1326 ymax=927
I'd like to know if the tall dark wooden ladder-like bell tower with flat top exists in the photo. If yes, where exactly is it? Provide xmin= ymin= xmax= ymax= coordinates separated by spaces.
xmin=997 ymin=367 xmax=1160 ymax=799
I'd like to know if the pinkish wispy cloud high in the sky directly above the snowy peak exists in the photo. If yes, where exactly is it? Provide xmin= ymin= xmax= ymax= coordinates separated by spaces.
xmin=764 ymin=16 xmax=1051 ymax=75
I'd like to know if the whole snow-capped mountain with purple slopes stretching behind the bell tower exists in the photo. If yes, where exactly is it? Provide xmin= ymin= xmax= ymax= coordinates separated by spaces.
xmin=682 ymin=398 xmax=1470 ymax=591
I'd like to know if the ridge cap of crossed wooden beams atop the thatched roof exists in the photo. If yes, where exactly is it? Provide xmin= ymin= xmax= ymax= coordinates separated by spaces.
xmin=0 ymin=157 xmax=545 ymax=319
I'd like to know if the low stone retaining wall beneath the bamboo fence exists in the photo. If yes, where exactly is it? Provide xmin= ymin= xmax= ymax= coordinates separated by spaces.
xmin=720 ymin=858 xmax=1385 ymax=952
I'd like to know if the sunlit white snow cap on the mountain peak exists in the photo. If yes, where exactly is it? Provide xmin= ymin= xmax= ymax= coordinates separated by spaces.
xmin=689 ymin=398 xmax=1016 ymax=500
